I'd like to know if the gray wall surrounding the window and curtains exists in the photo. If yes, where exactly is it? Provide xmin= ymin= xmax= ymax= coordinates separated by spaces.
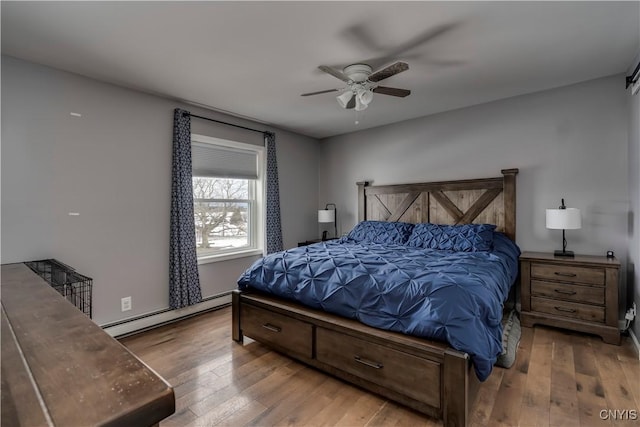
xmin=1 ymin=56 xmax=319 ymax=324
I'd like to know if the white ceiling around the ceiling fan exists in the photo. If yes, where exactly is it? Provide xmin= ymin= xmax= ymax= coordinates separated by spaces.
xmin=1 ymin=1 xmax=640 ymax=138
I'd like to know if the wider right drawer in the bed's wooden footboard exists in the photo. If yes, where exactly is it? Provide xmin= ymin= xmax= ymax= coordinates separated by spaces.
xmin=316 ymin=328 xmax=441 ymax=408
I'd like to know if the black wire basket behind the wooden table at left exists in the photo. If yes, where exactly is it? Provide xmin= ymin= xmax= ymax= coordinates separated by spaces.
xmin=25 ymin=259 xmax=93 ymax=318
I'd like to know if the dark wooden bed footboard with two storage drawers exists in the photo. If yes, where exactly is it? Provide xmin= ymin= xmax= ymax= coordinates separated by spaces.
xmin=232 ymin=291 xmax=478 ymax=426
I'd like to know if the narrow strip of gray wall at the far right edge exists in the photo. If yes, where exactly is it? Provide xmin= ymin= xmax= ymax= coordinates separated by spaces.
xmin=627 ymin=52 xmax=640 ymax=339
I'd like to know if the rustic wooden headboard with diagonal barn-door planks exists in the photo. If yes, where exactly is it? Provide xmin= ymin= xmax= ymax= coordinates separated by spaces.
xmin=357 ymin=169 xmax=518 ymax=241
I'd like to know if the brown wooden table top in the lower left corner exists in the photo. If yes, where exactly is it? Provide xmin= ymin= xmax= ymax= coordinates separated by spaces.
xmin=1 ymin=264 xmax=175 ymax=426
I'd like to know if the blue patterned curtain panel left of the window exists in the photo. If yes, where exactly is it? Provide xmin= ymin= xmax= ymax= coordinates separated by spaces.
xmin=169 ymin=108 xmax=202 ymax=310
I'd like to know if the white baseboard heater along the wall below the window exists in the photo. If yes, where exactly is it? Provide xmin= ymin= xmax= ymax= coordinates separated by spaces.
xmin=101 ymin=293 xmax=231 ymax=337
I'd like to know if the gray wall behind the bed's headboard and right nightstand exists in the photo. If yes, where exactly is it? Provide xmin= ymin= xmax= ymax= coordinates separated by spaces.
xmin=319 ymin=75 xmax=638 ymax=318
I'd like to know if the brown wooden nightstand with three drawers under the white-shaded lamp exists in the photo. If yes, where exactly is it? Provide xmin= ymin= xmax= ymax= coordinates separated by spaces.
xmin=520 ymin=252 xmax=620 ymax=345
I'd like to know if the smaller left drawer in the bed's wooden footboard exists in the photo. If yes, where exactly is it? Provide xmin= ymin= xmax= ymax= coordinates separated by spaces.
xmin=240 ymin=304 xmax=313 ymax=358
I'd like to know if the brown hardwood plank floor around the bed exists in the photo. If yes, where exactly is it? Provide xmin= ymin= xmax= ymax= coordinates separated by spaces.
xmin=121 ymin=308 xmax=640 ymax=427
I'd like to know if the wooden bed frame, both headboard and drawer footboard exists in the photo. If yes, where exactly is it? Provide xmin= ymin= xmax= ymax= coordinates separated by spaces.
xmin=232 ymin=169 xmax=518 ymax=426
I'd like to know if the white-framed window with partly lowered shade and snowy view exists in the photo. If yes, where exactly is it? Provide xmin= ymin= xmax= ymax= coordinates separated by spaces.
xmin=191 ymin=134 xmax=264 ymax=262
